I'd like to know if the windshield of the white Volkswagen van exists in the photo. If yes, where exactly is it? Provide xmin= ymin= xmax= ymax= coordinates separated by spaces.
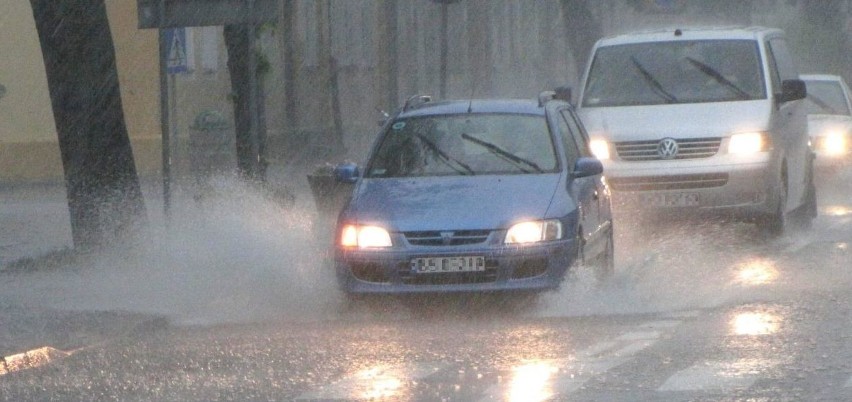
xmin=582 ymin=40 xmax=766 ymax=107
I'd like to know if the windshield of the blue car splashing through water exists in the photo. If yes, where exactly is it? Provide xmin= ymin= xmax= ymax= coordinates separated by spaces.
xmin=366 ymin=114 xmax=559 ymax=177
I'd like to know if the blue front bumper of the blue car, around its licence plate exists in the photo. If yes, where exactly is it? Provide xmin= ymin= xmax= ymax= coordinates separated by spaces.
xmin=335 ymin=239 xmax=577 ymax=294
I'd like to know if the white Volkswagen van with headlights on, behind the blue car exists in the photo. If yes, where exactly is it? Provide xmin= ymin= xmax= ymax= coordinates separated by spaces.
xmin=577 ymin=27 xmax=816 ymax=234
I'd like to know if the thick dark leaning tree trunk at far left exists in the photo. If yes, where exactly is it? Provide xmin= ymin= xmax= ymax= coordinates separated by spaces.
xmin=30 ymin=0 xmax=145 ymax=249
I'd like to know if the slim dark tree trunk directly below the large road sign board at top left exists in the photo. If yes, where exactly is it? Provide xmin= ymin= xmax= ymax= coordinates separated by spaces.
xmin=224 ymin=25 xmax=267 ymax=182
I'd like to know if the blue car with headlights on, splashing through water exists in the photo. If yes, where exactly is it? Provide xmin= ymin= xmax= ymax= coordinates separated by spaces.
xmin=335 ymin=92 xmax=614 ymax=295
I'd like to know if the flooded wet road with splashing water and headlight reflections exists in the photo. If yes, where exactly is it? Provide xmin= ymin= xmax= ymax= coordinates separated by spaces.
xmin=0 ymin=171 xmax=852 ymax=401
